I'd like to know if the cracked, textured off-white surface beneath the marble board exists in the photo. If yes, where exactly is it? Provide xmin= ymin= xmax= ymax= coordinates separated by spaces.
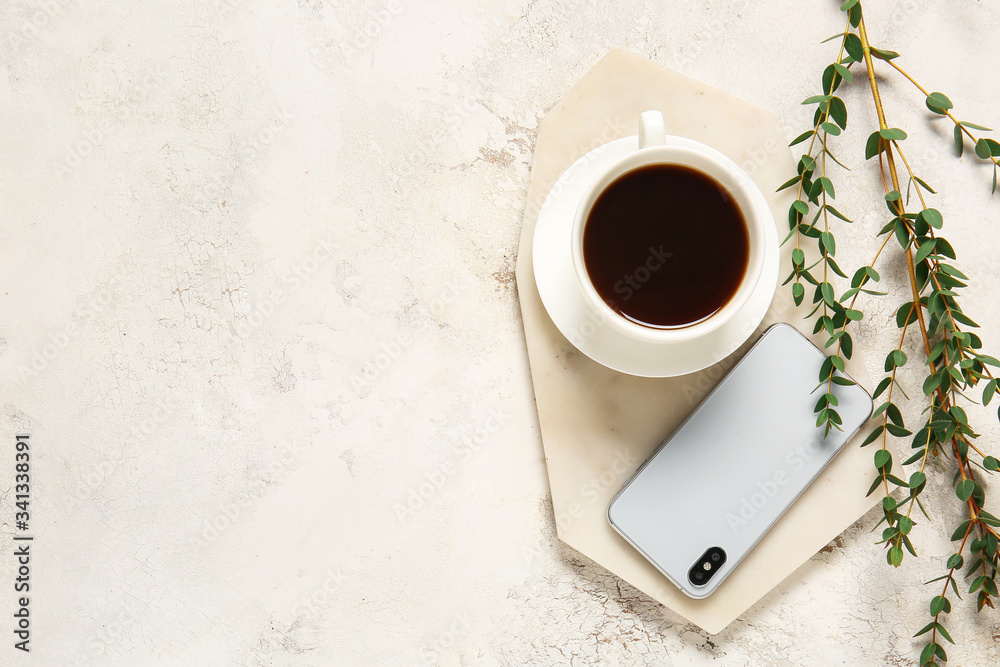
xmin=0 ymin=0 xmax=1000 ymax=665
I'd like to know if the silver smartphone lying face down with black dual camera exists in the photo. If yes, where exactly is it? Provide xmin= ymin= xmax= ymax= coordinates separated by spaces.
xmin=608 ymin=324 xmax=872 ymax=598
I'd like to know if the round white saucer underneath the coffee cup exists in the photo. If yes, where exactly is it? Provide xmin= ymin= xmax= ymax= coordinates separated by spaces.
xmin=532 ymin=136 xmax=779 ymax=377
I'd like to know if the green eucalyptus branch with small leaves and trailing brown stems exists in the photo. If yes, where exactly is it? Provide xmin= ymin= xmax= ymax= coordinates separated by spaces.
xmin=779 ymin=0 xmax=1000 ymax=665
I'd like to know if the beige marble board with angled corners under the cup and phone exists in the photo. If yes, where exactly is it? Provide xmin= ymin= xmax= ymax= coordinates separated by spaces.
xmin=517 ymin=50 xmax=874 ymax=634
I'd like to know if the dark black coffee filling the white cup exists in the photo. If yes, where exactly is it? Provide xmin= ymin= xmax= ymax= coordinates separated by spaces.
xmin=583 ymin=164 xmax=750 ymax=329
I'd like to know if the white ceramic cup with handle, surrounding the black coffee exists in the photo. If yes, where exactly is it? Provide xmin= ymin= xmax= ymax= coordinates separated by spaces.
xmin=571 ymin=111 xmax=777 ymax=344
